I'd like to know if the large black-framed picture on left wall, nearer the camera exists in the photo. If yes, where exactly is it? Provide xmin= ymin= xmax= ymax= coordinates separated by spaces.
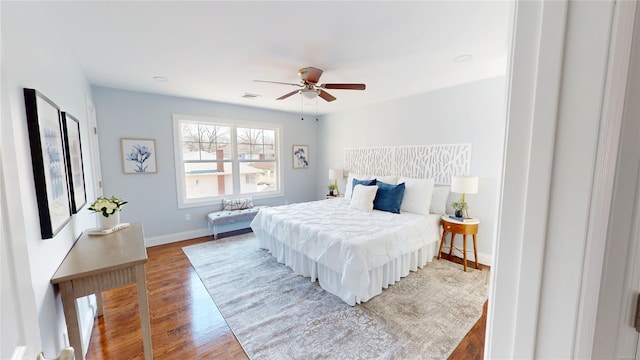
xmin=24 ymin=88 xmax=71 ymax=239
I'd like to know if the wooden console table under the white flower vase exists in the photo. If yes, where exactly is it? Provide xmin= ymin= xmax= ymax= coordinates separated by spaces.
xmin=51 ymin=223 xmax=153 ymax=360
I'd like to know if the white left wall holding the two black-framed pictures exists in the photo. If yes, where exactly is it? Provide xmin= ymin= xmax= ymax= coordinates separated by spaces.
xmin=0 ymin=2 xmax=95 ymax=358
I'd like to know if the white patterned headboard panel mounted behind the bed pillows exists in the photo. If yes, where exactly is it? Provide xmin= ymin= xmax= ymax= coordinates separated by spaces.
xmin=344 ymin=144 xmax=471 ymax=185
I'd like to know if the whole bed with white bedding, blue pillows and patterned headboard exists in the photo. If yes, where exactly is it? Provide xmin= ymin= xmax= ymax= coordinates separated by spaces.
xmin=251 ymin=144 xmax=471 ymax=306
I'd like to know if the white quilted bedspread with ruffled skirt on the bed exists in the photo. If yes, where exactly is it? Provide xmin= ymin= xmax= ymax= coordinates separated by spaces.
xmin=251 ymin=199 xmax=440 ymax=305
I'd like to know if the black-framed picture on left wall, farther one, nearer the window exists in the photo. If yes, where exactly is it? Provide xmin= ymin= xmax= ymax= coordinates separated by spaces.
xmin=62 ymin=111 xmax=87 ymax=214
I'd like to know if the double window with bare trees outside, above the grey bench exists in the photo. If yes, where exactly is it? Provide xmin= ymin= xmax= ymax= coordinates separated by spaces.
xmin=173 ymin=114 xmax=280 ymax=208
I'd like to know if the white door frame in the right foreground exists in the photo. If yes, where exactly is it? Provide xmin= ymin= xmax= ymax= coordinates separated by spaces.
xmin=485 ymin=0 xmax=635 ymax=358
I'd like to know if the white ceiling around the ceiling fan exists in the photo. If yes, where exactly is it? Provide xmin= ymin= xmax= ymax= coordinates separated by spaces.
xmin=45 ymin=1 xmax=511 ymax=114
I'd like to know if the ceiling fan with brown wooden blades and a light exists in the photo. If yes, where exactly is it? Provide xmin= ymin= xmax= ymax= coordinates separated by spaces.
xmin=253 ymin=66 xmax=366 ymax=101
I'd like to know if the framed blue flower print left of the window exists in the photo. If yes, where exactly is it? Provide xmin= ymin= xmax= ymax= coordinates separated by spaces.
xmin=120 ymin=138 xmax=157 ymax=174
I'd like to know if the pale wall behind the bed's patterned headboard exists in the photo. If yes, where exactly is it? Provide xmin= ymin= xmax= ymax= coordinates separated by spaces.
xmin=314 ymin=76 xmax=506 ymax=265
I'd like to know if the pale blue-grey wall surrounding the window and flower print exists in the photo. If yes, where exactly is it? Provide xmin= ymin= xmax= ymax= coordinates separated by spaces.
xmin=93 ymin=87 xmax=319 ymax=245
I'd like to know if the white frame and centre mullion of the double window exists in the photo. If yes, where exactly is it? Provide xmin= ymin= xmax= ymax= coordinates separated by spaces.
xmin=172 ymin=114 xmax=283 ymax=209
